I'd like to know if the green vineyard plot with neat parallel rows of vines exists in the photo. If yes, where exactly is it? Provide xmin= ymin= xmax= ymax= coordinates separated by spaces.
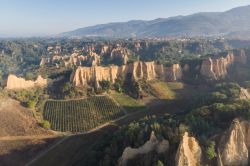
xmin=43 ymin=96 xmax=125 ymax=132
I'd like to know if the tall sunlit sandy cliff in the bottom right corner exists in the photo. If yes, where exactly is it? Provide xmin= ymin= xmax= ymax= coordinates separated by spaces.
xmin=218 ymin=119 xmax=250 ymax=166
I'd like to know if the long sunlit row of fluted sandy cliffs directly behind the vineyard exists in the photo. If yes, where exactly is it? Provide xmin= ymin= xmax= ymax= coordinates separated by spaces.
xmin=71 ymin=61 xmax=182 ymax=86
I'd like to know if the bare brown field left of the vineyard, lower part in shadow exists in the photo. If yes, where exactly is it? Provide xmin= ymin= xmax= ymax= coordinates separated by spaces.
xmin=0 ymin=98 xmax=56 ymax=166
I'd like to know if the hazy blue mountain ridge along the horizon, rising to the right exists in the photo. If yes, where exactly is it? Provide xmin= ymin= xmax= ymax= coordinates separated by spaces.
xmin=59 ymin=6 xmax=250 ymax=38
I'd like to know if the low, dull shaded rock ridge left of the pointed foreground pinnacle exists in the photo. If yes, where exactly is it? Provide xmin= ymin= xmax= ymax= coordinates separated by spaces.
xmin=118 ymin=132 xmax=169 ymax=166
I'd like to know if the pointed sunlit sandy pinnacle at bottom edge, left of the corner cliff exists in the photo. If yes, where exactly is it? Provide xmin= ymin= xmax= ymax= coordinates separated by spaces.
xmin=175 ymin=132 xmax=202 ymax=166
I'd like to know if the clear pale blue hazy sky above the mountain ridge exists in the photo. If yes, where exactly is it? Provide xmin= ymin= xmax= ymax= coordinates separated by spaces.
xmin=0 ymin=0 xmax=250 ymax=36
